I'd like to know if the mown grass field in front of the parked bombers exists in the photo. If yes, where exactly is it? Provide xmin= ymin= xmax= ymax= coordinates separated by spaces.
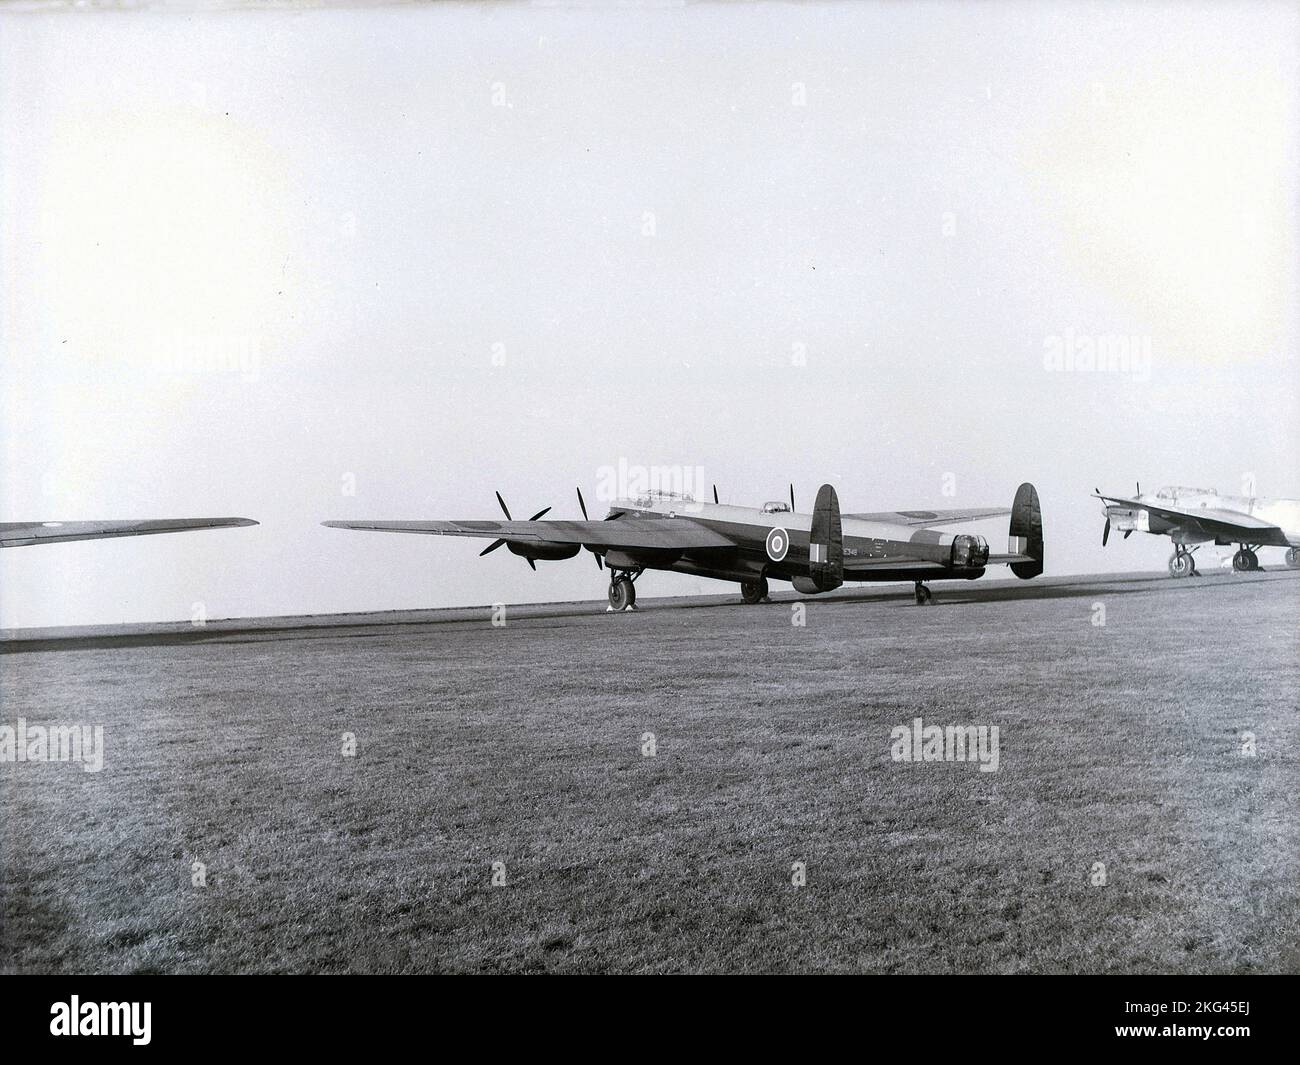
xmin=0 ymin=573 xmax=1300 ymax=973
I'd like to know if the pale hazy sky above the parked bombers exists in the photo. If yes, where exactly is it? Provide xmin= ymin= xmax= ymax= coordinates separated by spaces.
xmin=0 ymin=3 xmax=1300 ymax=627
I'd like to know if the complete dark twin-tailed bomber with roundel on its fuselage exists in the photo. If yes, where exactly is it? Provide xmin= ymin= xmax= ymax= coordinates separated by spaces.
xmin=322 ymin=484 xmax=1043 ymax=610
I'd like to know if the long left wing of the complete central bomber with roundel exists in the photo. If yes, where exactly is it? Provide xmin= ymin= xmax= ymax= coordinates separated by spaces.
xmin=321 ymin=518 xmax=736 ymax=550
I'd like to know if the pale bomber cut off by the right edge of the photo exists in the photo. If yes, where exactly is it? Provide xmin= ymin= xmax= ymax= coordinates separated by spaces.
xmin=1095 ymin=485 xmax=1300 ymax=577
